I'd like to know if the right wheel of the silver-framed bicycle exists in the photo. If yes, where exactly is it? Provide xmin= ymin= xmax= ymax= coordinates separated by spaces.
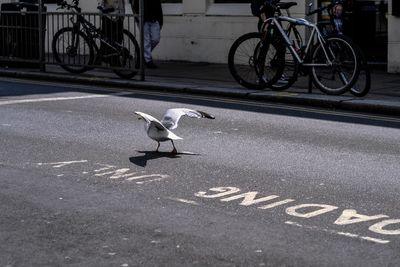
xmin=311 ymin=35 xmax=360 ymax=95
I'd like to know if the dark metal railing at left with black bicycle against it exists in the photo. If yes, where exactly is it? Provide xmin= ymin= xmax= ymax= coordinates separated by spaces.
xmin=0 ymin=0 xmax=144 ymax=80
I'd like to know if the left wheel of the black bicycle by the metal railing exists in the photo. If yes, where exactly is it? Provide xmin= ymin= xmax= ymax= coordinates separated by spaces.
xmin=52 ymin=27 xmax=94 ymax=73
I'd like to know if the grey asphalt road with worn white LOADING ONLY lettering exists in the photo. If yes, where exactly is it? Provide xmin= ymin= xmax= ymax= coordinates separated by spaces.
xmin=0 ymin=80 xmax=400 ymax=267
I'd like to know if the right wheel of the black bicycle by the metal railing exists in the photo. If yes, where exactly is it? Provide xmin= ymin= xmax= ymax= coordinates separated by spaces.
xmin=111 ymin=29 xmax=140 ymax=79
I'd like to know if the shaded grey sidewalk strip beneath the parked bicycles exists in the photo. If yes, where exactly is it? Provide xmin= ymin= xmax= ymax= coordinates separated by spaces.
xmin=0 ymin=61 xmax=400 ymax=117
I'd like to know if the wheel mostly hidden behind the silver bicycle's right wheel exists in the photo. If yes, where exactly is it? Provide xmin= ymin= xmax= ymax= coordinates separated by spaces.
xmin=350 ymin=46 xmax=371 ymax=97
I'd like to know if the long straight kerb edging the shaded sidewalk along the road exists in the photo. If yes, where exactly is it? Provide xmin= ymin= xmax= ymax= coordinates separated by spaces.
xmin=0 ymin=70 xmax=400 ymax=116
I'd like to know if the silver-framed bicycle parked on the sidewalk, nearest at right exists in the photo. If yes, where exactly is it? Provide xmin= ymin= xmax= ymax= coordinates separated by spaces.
xmin=228 ymin=0 xmax=359 ymax=95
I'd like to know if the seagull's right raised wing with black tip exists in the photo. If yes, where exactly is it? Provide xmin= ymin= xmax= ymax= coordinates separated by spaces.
xmin=161 ymin=108 xmax=215 ymax=130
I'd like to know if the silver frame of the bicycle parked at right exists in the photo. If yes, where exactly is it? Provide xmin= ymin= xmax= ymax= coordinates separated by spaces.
xmin=261 ymin=16 xmax=333 ymax=67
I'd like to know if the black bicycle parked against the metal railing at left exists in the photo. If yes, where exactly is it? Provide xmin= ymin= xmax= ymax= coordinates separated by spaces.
xmin=52 ymin=0 xmax=140 ymax=79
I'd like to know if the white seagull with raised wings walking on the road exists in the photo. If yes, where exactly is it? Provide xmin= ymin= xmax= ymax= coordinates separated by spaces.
xmin=135 ymin=108 xmax=215 ymax=154
